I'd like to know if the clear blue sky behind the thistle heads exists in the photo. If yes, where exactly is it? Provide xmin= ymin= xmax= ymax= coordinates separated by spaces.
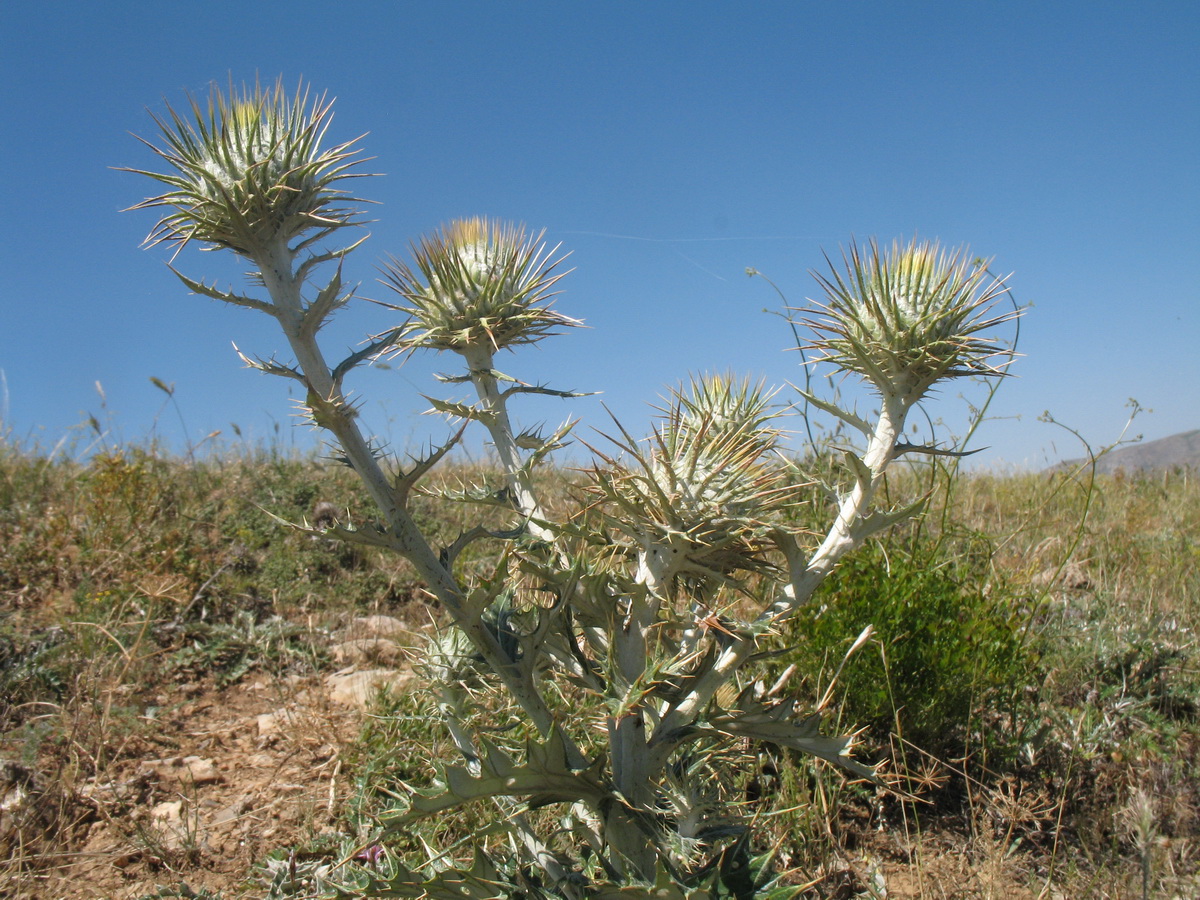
xmin=0 ymin=0 xmax=1200 ymax=466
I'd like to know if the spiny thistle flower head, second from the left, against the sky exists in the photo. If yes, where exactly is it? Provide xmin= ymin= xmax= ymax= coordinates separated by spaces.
xmin=384 ymin=217 xmax=581 ymax=352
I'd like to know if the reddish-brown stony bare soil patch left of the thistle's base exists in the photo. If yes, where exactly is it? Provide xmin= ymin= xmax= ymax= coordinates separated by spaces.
xmin=0 ymin=676 xmax=362 ymax=900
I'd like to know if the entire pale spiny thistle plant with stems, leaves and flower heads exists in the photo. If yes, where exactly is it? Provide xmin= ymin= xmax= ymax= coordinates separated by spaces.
xmin=126 ymin=85 xmax=1008 ymax=898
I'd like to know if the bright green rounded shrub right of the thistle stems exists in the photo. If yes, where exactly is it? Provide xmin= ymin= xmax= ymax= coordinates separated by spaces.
xmin=786 ymin=544 xmax=1036 ymax=758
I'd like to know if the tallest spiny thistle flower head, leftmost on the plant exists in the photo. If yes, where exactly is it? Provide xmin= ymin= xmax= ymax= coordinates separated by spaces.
xmin=127 ymin=80 xmax=362 ymax=262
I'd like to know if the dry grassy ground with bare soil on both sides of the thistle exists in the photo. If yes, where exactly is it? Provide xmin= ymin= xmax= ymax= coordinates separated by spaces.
xmin=0 ymin=434 xmax=1200 ymax=899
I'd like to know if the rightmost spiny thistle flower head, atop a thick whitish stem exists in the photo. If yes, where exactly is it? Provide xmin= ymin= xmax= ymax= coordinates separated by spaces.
xmin=804 ymin=240 xmax=1016 ymax=406
